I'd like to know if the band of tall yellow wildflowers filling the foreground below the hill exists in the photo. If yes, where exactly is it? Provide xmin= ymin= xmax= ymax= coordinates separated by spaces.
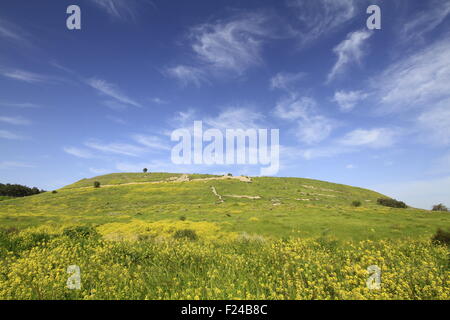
xmin=0 ymin=228 xmax=450 ymax=300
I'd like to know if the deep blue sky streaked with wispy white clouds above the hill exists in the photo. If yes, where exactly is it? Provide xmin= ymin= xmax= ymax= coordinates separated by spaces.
xmin=0 ymin=0 xmax=450 ymax=208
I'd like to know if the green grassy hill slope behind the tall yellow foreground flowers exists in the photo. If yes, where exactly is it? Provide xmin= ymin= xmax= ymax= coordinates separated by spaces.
xmin=0 ymin=173 xmax=450 ymax=240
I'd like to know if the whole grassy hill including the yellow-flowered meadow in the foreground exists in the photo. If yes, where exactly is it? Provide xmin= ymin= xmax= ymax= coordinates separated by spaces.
xmin=0 ymin=173 xmax=450 ymax=300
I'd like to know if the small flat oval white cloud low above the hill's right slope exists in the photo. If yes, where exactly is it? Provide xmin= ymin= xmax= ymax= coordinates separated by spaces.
xmin=338 ymin=128 xmax=398 ymax=148
